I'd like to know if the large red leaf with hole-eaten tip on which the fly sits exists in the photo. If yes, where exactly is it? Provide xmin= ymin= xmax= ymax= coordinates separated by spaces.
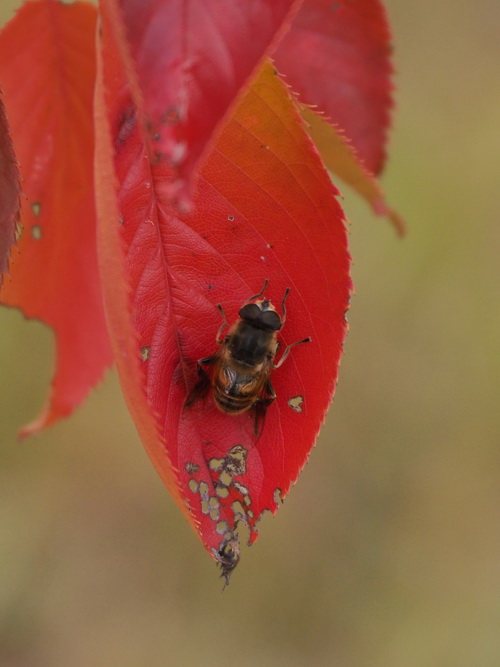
xmin=96 ymin=0 xmax=350 ymax=575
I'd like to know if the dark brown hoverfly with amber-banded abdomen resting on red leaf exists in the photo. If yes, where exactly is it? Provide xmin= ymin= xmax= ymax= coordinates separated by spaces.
xmin=186 ymin=280 xmax=311 ymax=435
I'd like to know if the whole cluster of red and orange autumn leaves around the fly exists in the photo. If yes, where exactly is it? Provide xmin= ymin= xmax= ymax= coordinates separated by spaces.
xmin=0 ymin=0 xmax=401 ymax=578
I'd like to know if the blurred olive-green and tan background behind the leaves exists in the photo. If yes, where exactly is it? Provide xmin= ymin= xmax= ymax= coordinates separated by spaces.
xmin=0 ymin=0 xmax=500 ymax=667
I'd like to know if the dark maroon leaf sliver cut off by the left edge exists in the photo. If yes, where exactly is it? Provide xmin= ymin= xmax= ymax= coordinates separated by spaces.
xmin=0 ymin=93 xmax=21 ymax=287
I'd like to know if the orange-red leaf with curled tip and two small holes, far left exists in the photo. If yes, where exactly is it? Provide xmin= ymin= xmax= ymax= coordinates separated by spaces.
xmin=0 ymin=0 xmax=112 ymax=435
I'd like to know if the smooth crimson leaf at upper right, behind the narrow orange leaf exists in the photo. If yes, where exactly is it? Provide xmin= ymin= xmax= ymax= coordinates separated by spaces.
xmin=274 ymin=0 xmax=392 ymax=174
